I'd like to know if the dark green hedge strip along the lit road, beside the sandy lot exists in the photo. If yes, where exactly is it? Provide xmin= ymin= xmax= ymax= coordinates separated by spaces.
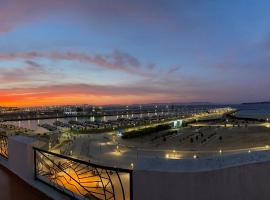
xmin=122 ymin=124 xmax=171 ymax=139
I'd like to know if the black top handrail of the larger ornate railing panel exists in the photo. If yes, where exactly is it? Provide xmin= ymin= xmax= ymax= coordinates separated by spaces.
xmin=33 ymin=147 xmax=133 ymax=174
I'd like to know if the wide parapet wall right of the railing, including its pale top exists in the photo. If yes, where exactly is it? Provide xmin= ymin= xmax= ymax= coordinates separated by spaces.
xmin=133 ymin=151 xmax=270 ymax=200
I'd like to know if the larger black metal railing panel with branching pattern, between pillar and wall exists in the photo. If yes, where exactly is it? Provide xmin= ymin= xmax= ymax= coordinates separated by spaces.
xmin=34 ymin=148 xmax=133 ymax=200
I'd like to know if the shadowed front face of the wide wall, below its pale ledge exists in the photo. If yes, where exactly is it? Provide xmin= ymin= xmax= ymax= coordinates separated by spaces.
xmin=133 ymin=162 xmax=270 ymax=200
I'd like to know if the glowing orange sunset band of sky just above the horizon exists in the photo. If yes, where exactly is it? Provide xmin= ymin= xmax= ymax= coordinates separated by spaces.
xmin=0 ymin=85 xmax=196 ymax=107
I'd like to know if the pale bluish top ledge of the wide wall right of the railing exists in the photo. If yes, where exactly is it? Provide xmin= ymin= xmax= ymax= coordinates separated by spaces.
xmin=135 ymin=150 xmax=270 ymax=172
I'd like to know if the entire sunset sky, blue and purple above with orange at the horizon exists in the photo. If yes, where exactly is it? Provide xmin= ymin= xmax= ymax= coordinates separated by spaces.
xmin=0 ymin=0 xmax=270 ymax=106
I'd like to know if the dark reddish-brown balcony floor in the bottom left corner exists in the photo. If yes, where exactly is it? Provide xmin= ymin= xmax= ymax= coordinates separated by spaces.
xmin=0 ymin=165 xmax=51 ymax=200
